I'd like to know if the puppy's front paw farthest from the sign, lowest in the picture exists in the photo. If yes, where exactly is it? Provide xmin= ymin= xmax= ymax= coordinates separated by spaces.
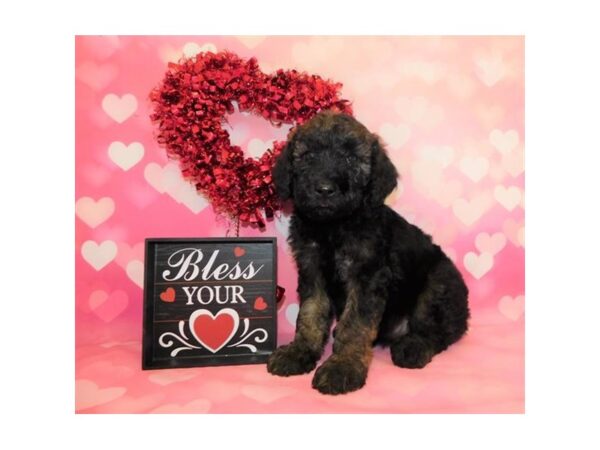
xmin=312 ymin=355 xmax=367 ymax=395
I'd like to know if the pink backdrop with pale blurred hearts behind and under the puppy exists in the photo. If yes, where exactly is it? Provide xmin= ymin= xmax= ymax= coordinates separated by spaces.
xmin=75 ymin=36 xmax=525 ymax=413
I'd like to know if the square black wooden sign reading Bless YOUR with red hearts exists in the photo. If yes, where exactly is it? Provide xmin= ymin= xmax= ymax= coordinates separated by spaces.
xmin=142 ymin=238 xmax=277 ymax=369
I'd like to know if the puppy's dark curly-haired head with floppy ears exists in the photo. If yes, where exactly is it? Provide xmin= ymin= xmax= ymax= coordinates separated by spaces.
xmin=273 ymin=111 xmax=398 ymax=222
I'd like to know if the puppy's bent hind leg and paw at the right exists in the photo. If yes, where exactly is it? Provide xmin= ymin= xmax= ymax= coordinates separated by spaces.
xmin=390 ymin=258 xmax=469 ymax=369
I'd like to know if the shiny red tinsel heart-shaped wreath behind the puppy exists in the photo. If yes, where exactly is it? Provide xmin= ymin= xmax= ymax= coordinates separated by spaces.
xmin=150 ymin=52 xmax=352 ymax=227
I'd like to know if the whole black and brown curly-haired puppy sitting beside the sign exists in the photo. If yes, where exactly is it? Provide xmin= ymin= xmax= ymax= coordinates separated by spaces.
xmin=267 ymin=112 xmax=469 ymax=394
